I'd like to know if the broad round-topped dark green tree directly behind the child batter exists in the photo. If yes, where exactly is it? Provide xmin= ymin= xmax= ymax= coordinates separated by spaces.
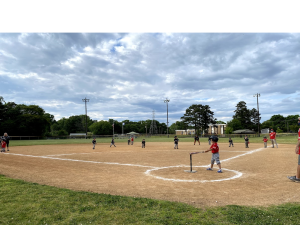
xmin=181 ymin=104 xmax=216 ymax=134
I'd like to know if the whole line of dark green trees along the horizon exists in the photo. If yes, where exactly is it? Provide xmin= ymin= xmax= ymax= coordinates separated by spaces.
xmin=0 ymin=96 xmax=299 ymax=136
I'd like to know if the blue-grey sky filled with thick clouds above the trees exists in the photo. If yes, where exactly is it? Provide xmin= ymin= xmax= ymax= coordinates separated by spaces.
xmin=0 ymin=32 xmax=300 ymax=124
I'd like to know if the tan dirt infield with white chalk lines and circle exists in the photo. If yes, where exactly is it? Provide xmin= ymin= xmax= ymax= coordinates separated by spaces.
xmin=0 ymin=142 xmax=300 ymax=207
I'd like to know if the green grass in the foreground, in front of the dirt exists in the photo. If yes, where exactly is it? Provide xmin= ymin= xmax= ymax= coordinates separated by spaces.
xmin=0 ymin=175 xmax=300 ymax=224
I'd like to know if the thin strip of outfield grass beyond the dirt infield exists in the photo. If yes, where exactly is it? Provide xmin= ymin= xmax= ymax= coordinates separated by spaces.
xmin=9 ymin=135 xmax=297 ymax=146
